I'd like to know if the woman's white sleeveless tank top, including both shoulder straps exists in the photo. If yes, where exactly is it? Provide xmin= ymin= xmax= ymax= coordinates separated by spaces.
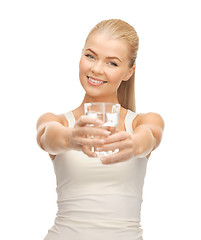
xmin=44 ymin=110 xmax=147 ymax=240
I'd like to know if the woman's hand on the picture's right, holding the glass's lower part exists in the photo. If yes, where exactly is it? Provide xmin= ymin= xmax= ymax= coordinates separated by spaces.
xmin=97 ymin=131 xmax=135 ymax=164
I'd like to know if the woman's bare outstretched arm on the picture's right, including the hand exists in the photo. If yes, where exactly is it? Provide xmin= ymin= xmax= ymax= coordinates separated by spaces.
xmin=99 ymin=113 xmax=164 ymax=164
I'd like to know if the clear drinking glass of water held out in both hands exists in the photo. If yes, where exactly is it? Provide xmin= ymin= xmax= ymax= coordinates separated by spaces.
xmin=84 ymin=102 xmax=120 ymax=157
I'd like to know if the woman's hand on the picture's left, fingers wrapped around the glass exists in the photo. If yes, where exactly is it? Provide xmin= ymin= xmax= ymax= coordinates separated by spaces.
xmin=68 ymin=115 xmax=111 ymax=157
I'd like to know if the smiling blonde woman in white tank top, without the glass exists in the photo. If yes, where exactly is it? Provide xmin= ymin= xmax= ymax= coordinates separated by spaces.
xmin=37 ymin=19 xmax=164 ymax=240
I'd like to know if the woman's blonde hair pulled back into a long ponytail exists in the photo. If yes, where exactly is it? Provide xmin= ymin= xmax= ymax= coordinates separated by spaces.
xmin=86 ymin=19 xmax=139 ymax=112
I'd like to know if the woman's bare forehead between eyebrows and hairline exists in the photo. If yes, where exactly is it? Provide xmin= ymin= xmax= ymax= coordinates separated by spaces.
xmin=85 ymin=33 xmax=128 ymax=60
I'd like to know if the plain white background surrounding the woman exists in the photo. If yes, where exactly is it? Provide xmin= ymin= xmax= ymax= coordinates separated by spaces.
xmin=0 ymin=0 xmax=201 ymax=240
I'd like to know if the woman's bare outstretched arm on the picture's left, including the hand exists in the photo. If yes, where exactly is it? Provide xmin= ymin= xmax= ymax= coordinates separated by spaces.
xmin=37 ymin=113 xmax=110 ymax=157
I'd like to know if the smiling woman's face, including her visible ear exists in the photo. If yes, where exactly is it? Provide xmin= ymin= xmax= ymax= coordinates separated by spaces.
xmin=79 ymin=33 xmax=134 ymax=100
